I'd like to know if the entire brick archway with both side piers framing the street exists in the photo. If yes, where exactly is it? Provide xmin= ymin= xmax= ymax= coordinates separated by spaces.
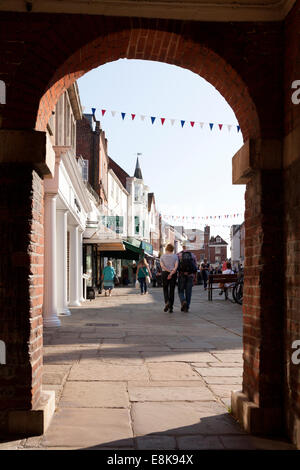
xmin=0 ymin=13 xmax=299 ymax=440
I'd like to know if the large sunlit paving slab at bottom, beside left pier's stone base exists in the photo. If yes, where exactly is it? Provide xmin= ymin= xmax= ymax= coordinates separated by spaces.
xmin=41 ymin=408 xmax=133 ymax=449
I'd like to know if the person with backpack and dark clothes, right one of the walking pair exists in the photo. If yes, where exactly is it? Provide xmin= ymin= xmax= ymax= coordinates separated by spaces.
xmin=177 ymin=245 xmax=197 ymax=312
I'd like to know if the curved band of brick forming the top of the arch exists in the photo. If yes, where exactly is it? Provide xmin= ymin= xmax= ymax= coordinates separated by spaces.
xmin=35 ymin=28 xmax=260 ymax=141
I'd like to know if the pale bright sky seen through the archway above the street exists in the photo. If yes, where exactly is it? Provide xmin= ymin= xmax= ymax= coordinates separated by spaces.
xmin=78 ymin=59 xmax=245 ymax=242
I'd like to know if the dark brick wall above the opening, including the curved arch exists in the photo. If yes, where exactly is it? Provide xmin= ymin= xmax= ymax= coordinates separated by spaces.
xmin=0 ymin=13 xmax=283 ymax=140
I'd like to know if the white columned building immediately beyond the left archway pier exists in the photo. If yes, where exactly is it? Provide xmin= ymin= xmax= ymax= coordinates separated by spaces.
xmin=43 ymin=84 xmax=91 ymax=327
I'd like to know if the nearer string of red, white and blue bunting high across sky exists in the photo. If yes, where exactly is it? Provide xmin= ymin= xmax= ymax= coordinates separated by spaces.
xmin=91 ymin=108 xmax=241 ymax=133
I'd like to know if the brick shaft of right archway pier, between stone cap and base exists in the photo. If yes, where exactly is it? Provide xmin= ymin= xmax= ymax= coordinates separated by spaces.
xmin=243 ymin=170 xmax=284 ymax=414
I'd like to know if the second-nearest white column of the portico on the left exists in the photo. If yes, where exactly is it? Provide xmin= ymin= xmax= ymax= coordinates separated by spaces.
xmin=56 ymin=209 xmax=71 ymax=316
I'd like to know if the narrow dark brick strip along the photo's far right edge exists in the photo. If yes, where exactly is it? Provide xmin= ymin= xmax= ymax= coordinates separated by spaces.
xmin=284 ymin=1 xmax=300 ymax=445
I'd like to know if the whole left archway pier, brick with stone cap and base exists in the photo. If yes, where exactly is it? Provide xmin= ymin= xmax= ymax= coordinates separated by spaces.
xmin=0 ymin=129 xmax=55 ymax=435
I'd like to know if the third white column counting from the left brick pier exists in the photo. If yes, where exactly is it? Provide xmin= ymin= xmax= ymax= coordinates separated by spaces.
xmin=69 ymin=225 xmax=80 ymax=307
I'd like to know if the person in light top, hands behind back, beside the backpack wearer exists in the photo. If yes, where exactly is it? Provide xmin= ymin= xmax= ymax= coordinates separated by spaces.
xmin=160 ymin=243 xmax=179 ymax=313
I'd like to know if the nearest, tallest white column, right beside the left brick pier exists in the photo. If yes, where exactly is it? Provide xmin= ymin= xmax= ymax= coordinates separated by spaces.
xmin=43 ymin=193 xmax=60 ymax=328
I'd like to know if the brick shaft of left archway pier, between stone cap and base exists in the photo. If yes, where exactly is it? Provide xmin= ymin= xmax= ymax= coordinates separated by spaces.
xmin=0 ymin=164 xmax=44 ymax=427
